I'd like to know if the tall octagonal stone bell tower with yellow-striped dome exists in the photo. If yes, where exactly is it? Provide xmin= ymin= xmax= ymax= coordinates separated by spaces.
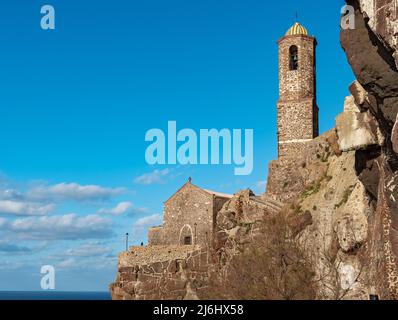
xmin=278 ymin=23 xmax=319 ymax=158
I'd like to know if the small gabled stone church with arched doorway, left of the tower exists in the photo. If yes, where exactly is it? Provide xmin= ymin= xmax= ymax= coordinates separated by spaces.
xmin=148 ymin=180 xmax=232 ymax=247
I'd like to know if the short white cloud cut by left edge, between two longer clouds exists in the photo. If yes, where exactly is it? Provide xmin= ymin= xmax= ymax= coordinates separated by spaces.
xmin=0 ymin=200 xmax=55 ymax=216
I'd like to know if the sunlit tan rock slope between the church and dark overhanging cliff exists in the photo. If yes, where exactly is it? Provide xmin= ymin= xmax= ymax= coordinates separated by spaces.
xmin=215 ymin=118 xmax=383 ymax=299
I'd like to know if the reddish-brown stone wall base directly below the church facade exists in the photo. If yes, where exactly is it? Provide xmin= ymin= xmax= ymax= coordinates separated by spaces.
xmin=110 ymin=246 xmax=210 ymax=300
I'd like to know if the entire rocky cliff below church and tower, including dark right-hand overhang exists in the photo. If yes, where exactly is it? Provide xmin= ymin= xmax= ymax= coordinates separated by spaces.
xmin=111 ymin=0 xmax=398 ymax=299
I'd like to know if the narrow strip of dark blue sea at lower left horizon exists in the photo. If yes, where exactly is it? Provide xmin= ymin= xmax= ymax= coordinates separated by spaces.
xmin=0 ymin=291 xmax=111 ymax=300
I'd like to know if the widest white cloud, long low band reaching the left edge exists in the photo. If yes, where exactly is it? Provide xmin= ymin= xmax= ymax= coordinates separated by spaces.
xmin=0 ymin=214 xmax=113 ymax=240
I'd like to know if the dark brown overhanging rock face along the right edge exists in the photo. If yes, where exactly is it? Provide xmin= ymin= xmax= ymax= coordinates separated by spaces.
xmin=341 ymin=0 xmax=398 ymax=299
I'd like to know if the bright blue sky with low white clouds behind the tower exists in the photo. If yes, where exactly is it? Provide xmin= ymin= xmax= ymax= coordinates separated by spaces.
xmin=0 ymin=0 xmax=354 ymax=291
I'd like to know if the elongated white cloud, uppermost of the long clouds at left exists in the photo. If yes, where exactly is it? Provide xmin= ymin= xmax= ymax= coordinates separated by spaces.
xmin=28 ymin=183 xmax=125 ymax=201
